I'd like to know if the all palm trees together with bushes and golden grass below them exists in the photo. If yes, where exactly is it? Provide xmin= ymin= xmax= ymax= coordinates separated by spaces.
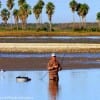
xmin=0 ymin=0 xmax=100 ymax=36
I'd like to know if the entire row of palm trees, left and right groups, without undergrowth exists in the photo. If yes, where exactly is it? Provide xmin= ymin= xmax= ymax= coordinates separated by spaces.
xmin=0 ymin=0 xmax=100 ymax=31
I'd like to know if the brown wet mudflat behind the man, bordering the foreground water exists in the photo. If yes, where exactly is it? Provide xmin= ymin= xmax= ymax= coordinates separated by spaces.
xmin=0 ymin=57 xmax=100 ymax=70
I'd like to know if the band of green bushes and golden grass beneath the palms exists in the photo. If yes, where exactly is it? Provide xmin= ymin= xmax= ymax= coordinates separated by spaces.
xmin=0 ymin=23 xmax=100 ymax=36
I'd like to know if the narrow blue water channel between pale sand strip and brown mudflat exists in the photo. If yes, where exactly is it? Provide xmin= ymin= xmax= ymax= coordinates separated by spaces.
xmin=0 ymin=53 xmax=100 ymax=58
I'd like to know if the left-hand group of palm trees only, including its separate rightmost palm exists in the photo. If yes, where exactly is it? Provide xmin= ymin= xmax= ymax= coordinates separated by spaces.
xmin=0 ymin=0 xmax=55 ymax=31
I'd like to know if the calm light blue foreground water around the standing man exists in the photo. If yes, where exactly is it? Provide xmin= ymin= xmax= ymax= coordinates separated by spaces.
xmin=0 ymin=69 xmax=100 ymax=100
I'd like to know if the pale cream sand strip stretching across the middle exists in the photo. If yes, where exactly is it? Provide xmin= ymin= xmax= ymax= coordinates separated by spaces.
xmin=0 ymin=43 xmax=100 ymax=52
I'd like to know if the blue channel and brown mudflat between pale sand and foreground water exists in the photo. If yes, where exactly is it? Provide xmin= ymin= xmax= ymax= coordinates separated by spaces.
xmin=0 ymin=53 xmax=100 ymax=70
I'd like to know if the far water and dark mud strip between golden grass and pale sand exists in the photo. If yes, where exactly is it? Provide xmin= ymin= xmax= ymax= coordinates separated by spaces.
xmin=0 ymin=36 xmax=100 ymax=43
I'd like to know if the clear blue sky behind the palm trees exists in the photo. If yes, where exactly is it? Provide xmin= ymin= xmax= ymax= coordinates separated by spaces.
xmin=1 ymin=0 xmax=100 ymax=23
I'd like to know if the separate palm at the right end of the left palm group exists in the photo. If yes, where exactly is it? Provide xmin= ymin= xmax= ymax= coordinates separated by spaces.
xmin=46 ymin=2 xmax=55 ymax=31
